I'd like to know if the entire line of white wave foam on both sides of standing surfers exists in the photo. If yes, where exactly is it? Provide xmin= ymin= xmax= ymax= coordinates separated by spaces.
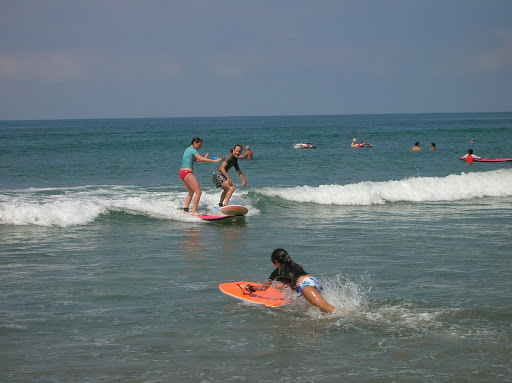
xmin=0 ymin=169 xmax=512 ymax=227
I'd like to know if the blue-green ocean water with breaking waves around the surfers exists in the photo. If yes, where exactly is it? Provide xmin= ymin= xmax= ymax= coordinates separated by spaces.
xmin=0 ymin=113 xmax=512 ymax=382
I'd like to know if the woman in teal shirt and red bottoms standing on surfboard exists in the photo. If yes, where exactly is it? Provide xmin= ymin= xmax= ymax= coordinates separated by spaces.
xmin=179 ymin=137 xmax=222 ymax=215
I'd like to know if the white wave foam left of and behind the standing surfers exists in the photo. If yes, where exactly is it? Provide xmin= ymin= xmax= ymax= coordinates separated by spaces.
xmin=0 ymin=186 xmax=256 ymax=227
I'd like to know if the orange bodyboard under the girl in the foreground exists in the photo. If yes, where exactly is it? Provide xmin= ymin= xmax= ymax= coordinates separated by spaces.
xmin=219 ymin=281 xmax=292 ymax=307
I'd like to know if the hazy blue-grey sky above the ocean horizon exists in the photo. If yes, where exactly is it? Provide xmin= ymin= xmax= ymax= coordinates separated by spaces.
xmin=0 ymin=0 xmax=512 ymax=120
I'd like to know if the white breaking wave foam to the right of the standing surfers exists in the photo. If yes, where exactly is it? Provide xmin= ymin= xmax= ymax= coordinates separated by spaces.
xmin=258 ymin=169 xmax=512 ymax=206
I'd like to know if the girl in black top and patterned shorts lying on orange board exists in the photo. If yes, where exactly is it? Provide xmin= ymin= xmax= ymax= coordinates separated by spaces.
xmin=245 ymin=249 xmax=349 ymax=314
